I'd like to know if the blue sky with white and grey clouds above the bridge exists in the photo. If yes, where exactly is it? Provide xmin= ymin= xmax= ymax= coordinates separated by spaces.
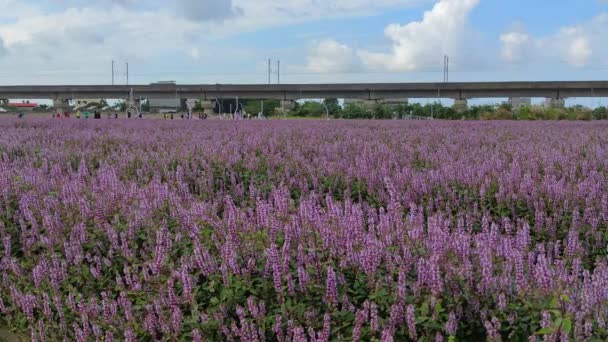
xmin=0 ymin=0 xmax=608 ymax=84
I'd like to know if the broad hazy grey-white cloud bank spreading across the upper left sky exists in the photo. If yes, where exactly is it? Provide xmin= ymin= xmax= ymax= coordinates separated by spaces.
xmin=0 ymin=0 xmax=430 ymax=83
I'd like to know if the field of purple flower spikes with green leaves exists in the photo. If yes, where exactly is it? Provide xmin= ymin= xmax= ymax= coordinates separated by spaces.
xmin=0 ymin=119 xmax=608 ymax=342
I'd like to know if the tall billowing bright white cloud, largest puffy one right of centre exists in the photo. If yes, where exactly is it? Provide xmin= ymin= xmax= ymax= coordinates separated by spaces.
xmin=359 ymin=0 xmax=479 ymax=71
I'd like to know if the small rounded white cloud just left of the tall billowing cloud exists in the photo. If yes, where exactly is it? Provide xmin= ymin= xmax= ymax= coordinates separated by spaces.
xmin=307 ymin=39 xmax=357 ymax=72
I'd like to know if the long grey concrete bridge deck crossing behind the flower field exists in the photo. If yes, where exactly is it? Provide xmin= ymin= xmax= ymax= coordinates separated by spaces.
xmin=0 ymin=81 xmax=608 ymax=101
